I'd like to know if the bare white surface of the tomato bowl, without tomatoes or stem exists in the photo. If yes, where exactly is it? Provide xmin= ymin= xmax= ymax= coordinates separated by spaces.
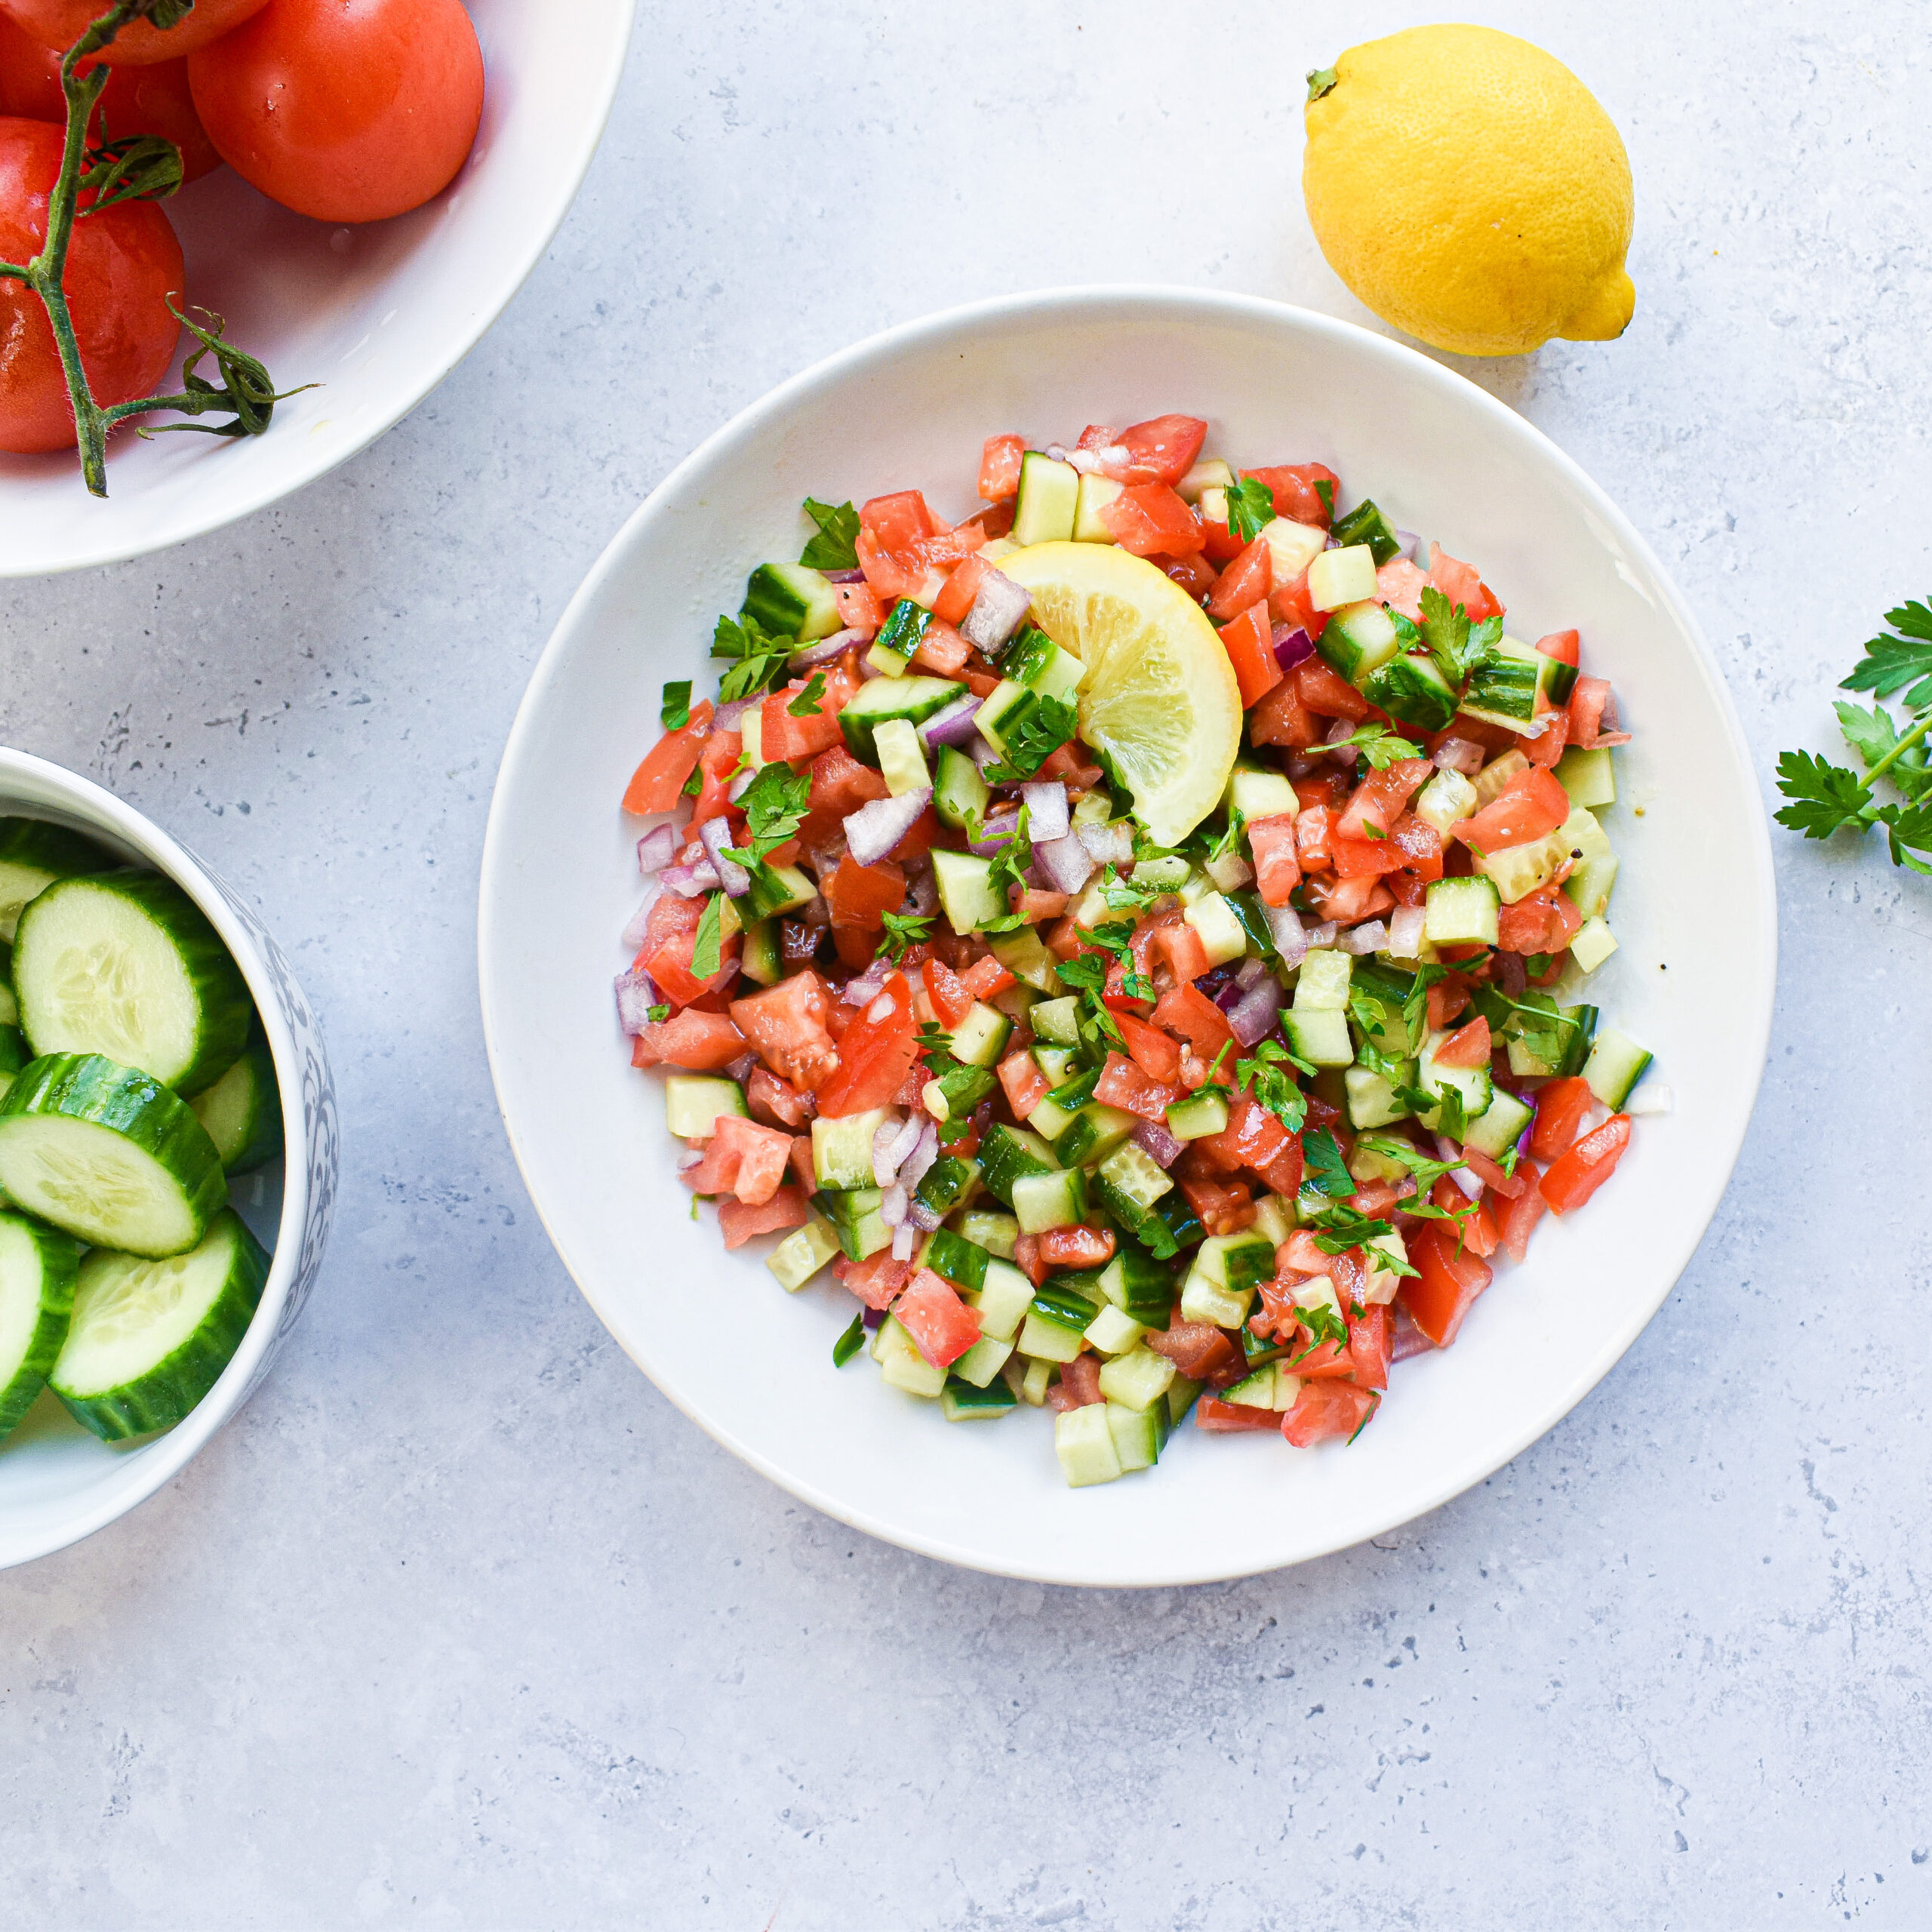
xmin=0 ymin=0 xmax=634 ymax=576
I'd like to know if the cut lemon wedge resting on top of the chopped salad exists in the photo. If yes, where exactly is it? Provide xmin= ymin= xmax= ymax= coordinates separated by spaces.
xmin=999 ymin=543 xmax=1241 ymax=846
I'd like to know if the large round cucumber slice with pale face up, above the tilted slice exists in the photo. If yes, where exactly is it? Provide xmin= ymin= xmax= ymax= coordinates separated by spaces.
xmin=14 ymin=869 xmax=255 ymax=1094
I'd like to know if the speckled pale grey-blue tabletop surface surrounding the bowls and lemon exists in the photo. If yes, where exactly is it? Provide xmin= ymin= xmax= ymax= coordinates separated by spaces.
xmin=0 ymin=0 xmax=1932 ymax=1932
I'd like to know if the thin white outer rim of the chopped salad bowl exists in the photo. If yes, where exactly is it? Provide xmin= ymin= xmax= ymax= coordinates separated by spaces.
xmin=477 ymin=284 xmax=1777 ymax=1588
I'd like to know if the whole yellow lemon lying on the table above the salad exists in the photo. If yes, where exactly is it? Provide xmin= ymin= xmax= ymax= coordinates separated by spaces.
xmin=1302 ymin=27 xmax=1636 ymax=355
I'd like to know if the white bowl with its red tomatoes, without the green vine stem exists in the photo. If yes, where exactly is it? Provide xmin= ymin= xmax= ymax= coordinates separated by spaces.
xmin=0 ymin=0 xmax=634 ymax=576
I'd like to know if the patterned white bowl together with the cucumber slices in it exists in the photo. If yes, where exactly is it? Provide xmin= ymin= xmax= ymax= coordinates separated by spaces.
xmin=0 ymin=749 xmax=336 ymax=1567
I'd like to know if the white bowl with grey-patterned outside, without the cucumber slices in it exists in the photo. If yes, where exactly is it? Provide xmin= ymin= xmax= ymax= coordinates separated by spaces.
xmin=0 ymin=748 xmax=340 ymax=1569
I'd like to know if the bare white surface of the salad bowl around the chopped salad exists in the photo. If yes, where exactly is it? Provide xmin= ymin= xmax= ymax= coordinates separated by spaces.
xmin=481 ymin=292 xmax=1774 ymax=1584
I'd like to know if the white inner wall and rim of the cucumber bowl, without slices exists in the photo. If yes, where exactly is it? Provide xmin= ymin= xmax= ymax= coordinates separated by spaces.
xmin=0 ymin=752 xmax=303 ymax=1567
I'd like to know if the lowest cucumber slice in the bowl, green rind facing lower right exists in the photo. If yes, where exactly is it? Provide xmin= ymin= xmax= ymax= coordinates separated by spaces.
xmin=46 ymin=1208 xmax=269 ymax=1443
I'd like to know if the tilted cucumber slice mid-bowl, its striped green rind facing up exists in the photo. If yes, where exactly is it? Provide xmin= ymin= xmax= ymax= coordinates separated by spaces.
xmin=0 ymin=1053 xmax=228 ymax=1258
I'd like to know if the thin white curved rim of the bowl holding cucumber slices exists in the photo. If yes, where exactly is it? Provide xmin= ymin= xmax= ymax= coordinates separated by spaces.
xmin=0 ymin=746 xmax=327 ymax=1565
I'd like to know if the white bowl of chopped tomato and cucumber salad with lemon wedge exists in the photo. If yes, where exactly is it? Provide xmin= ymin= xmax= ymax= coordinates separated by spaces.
xmin=481 ymin=290 xmax=1776 ymax=1584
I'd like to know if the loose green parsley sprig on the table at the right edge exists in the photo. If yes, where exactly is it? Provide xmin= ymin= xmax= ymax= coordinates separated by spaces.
xmin=1777 ymin=603 xmax=1932 ymax=877
